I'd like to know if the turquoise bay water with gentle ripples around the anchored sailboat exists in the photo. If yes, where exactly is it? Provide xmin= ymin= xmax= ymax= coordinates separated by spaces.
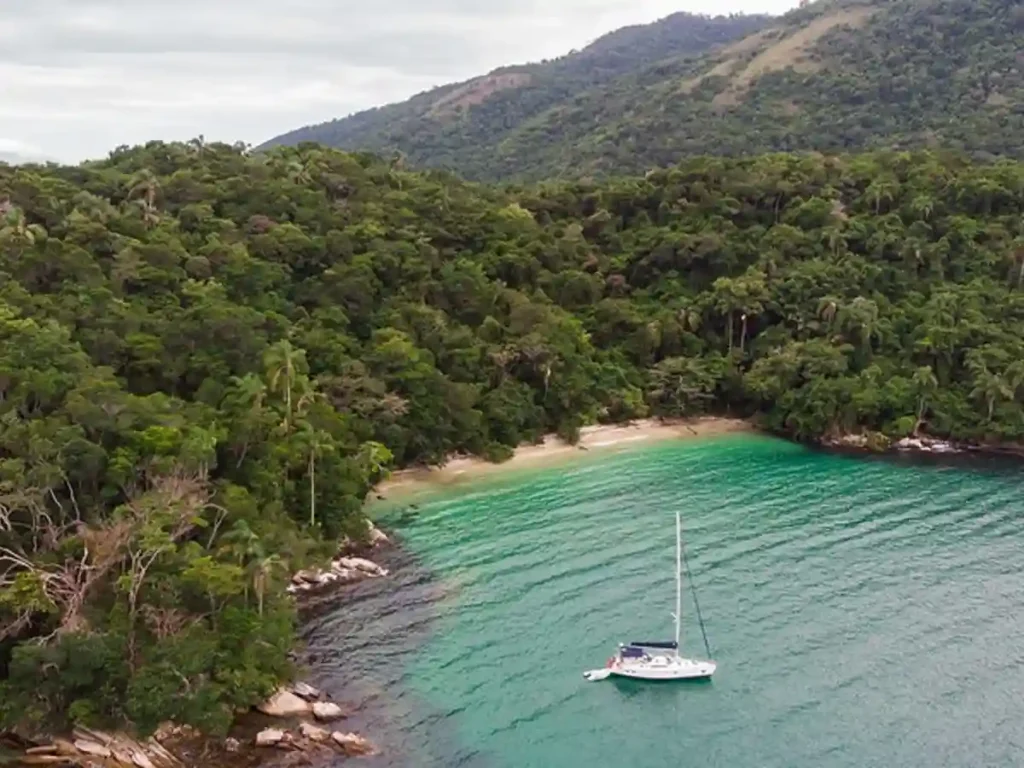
xmin=312 ymin=435 xmax=1024 ymax=768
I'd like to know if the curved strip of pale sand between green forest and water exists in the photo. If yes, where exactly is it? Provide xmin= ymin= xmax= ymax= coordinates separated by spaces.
xmin=376 ymin=417 xmax=755 ymax=499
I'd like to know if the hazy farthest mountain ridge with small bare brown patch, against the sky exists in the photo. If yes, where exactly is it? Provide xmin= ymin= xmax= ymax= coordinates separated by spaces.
xmin=260 ymin=13 xmax=771 ymax=177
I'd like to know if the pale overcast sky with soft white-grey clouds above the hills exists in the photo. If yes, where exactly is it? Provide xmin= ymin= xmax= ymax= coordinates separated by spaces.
xmin=0 ymin=0 xmax=796 ymax=163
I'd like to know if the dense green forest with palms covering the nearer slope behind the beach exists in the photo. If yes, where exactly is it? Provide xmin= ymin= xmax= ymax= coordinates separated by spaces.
xmin=0 ymin=141 xmax=1024 ymax=729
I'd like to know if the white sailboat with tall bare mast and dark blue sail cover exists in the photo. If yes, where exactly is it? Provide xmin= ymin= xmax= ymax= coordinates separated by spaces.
xmin=583 ymin=512 xmax=718 ymax=681
